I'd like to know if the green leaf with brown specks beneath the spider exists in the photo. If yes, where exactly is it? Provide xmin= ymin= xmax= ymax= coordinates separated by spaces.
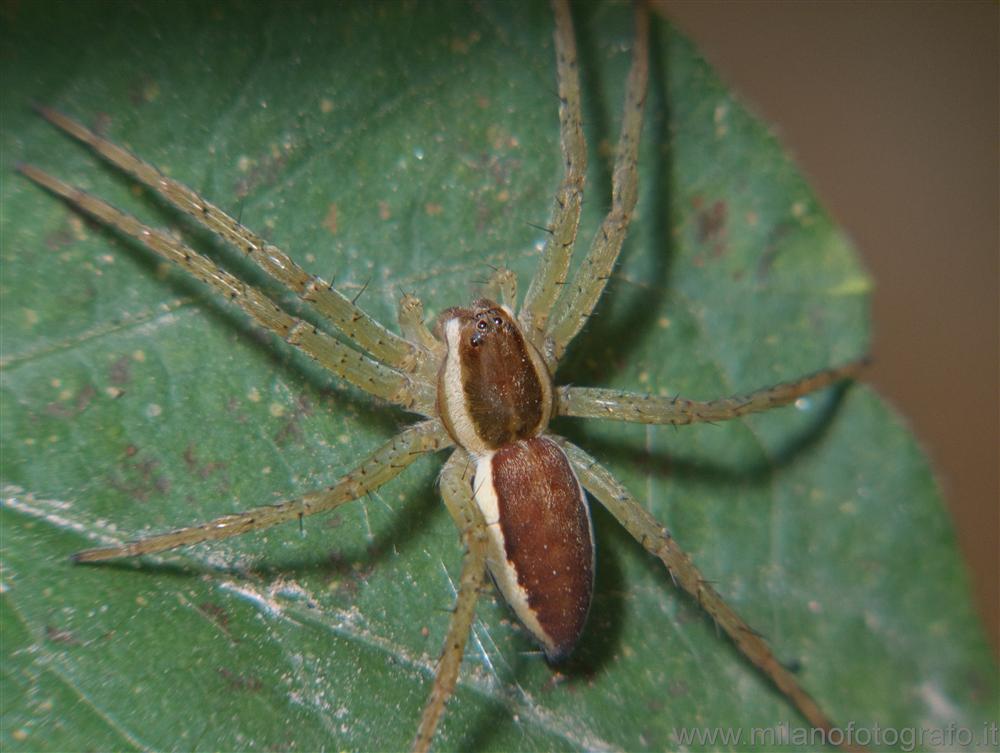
xmin=0 ymin=2 xmax=998 ymax=751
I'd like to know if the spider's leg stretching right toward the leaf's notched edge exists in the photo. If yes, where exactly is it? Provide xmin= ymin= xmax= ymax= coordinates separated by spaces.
xmin=556 ymin=358 xmax=869 ymax=424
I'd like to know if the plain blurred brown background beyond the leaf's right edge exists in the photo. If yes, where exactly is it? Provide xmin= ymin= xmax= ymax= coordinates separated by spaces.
xmin=658 ymin=0 xmax=1000 ymax=650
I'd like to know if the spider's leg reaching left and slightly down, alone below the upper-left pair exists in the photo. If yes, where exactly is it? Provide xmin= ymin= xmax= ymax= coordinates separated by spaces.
xmin=73 ymin=420 xmax=451 ymax=562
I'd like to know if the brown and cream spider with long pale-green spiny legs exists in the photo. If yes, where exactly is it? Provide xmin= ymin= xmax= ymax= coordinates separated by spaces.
xmin=20 ymin=0 xmax=865 ymax=750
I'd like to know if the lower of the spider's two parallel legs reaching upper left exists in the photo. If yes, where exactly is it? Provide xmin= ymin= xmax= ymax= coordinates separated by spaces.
xmin=18 ymin=165 xmax=435 ymax=415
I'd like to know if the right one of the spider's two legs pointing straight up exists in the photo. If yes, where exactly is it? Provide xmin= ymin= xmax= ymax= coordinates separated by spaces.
xmin=545 ymin=2 xmax=649 ymax=361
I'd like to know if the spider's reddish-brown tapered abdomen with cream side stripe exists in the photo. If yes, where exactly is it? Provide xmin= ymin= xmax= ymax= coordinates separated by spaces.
xmin=474 ymin=437 xmax=594 ymax=661
